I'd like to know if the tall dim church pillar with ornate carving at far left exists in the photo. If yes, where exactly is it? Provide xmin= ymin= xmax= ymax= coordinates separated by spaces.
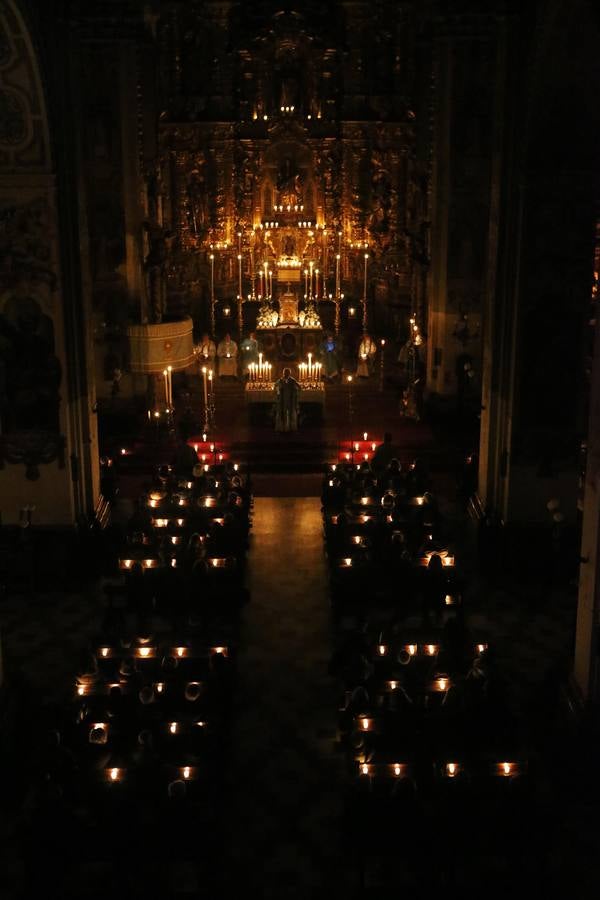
xmin=0 ymin=2 xmax=99 ymax=527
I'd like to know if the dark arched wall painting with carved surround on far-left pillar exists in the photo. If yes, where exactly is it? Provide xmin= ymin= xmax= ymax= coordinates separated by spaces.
xmin=0 ymin=200 xmax=63 ymax=479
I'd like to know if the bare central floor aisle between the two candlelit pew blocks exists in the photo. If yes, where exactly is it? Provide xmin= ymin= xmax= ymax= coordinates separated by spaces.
xmin=223 ymin=497 xmax=345 ymax=900
